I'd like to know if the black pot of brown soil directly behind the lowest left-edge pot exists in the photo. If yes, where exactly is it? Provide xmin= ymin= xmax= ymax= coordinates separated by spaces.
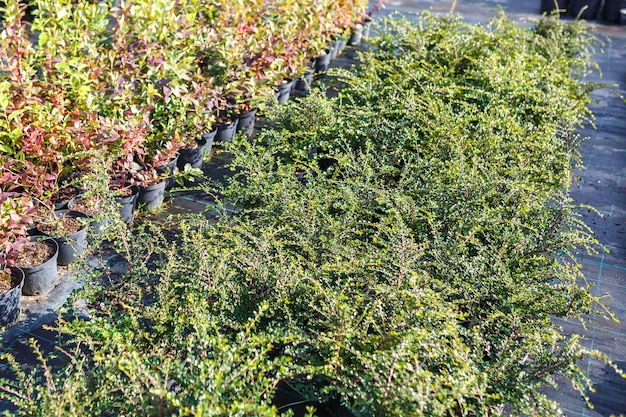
xmin=15 ymin=239 xmax=59 ymax=295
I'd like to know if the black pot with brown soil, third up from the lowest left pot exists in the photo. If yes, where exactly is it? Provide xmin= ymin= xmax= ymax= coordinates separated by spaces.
xmin=38 ymin=210 xmax=88 ymax=266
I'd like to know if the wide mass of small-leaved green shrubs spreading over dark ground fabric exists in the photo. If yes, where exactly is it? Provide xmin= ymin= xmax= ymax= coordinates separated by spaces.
xmin=0 ymin=9 xmax=612 ymax=416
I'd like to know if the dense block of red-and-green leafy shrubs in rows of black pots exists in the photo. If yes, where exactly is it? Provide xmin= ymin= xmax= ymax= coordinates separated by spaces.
xmin=0 ymin=0 xmax=372 ymax=324
